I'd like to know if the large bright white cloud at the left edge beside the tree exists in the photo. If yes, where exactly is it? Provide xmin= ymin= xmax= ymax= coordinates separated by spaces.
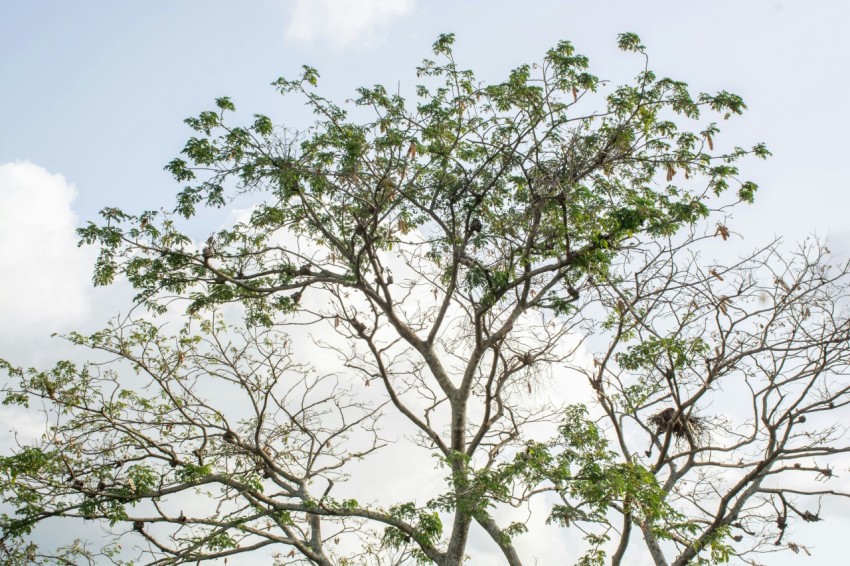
xmin=0 ymin=162 xmax=92 ymax=343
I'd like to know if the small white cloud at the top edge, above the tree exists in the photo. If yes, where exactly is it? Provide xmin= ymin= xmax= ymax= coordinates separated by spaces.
xmin=286 ymin=0 xmax=415 ymax=48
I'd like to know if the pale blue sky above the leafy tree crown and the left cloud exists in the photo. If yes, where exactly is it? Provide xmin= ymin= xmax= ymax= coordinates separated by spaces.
xmin=0 ymin=0 xmax=850 ymax=225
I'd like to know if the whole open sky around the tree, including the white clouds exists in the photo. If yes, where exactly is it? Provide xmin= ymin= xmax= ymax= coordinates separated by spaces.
xmin=0 ymin=0 xmax=850 ymax=564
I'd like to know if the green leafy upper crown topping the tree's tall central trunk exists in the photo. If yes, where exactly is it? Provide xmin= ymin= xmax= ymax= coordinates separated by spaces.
xmin=69 ymin=33 xmax=768 ymax=332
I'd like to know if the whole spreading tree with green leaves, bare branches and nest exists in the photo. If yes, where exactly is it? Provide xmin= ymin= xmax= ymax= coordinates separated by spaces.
xmin=0 ymin=34 xmax=850 ymax=565
